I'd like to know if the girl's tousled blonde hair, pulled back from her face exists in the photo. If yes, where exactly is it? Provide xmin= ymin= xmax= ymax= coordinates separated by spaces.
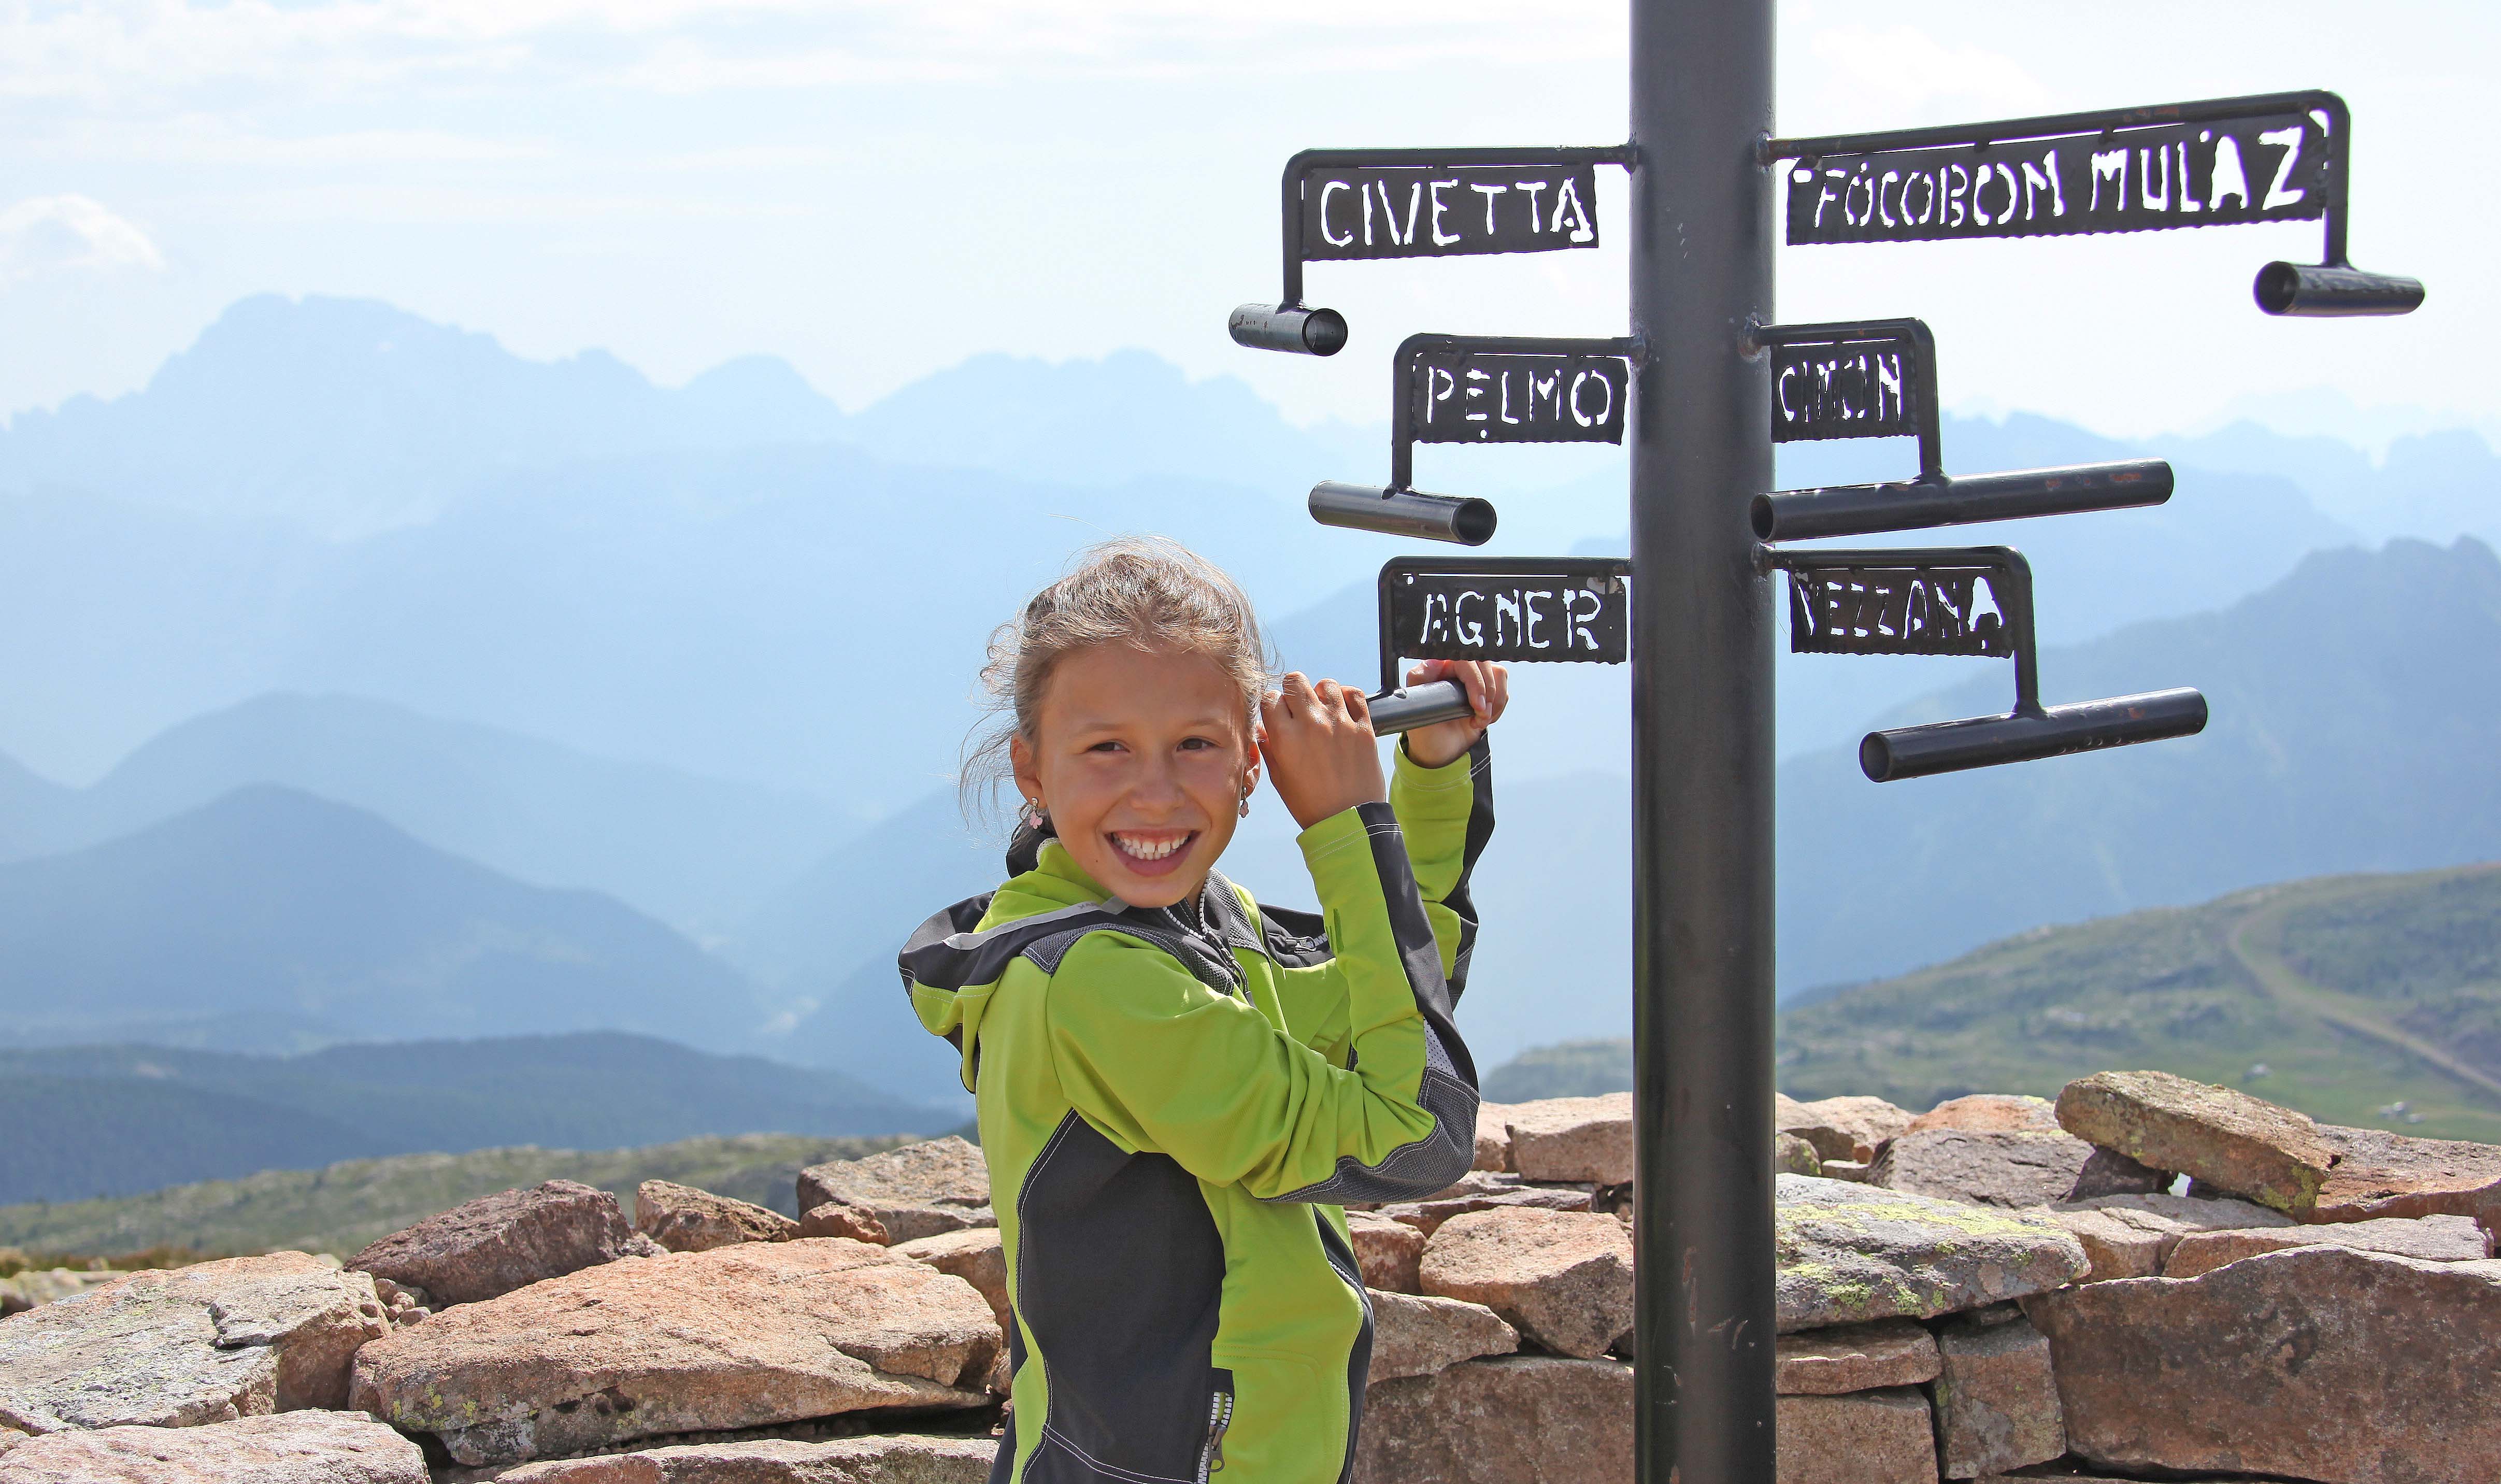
xmin=961 ymin=536 xmax=1270 ymax=814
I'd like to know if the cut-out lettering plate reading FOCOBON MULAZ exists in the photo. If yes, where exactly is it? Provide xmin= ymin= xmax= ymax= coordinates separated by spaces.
xmin=1788 ymin=112 xmax=2343 ymax=242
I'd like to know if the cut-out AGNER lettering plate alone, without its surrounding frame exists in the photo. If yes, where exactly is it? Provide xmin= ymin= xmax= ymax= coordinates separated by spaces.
xmin=1391 ymin=573 xmax=1631 ymax=666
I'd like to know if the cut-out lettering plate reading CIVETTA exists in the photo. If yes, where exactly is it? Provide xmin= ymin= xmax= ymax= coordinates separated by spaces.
xmin=1303 ymin=165 xmax=1598 ymax=260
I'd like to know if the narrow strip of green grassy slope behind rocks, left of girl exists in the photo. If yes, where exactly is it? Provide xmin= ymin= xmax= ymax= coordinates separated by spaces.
xmin=0 ymin=1134 xmax=908 ymax=1256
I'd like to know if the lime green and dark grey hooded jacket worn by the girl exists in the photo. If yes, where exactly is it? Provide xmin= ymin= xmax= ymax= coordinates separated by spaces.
xmin=901 ymin=743 xmax=1493 ymax=1484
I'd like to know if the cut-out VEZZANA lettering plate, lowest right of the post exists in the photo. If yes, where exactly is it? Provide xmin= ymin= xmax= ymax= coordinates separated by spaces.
xmin=1788 ymin=566 xmax=2016 ymax=658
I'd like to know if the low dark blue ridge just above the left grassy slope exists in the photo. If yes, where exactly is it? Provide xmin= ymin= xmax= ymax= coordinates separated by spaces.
xmin=0 ymin=1031 xmax=958 ymax=1204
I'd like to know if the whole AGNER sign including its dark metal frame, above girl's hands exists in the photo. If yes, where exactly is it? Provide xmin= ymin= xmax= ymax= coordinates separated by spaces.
xmin=1381 ymin=555 xmax=1633 ymax=691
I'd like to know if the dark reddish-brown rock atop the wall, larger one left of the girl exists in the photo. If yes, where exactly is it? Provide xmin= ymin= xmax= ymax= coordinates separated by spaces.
xmin=348 ymin=1181 xmax=655 ymax=1304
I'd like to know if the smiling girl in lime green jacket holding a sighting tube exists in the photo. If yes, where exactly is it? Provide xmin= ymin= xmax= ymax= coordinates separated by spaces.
xmin=903 ymin=540 xmax=1506 ymax=1484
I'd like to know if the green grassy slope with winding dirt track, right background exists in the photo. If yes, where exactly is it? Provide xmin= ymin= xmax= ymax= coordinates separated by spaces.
xmin=1485 ymin=866 xmax=2501 ymax=1144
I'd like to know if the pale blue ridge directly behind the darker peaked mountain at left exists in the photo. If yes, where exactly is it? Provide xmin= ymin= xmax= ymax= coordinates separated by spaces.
xmin=0 ymin=693 xmax=860 ymax=933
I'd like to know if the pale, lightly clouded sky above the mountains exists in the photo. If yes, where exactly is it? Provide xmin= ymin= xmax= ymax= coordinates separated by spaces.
xmin=0 ymin=0 xmax=2501 ymax=443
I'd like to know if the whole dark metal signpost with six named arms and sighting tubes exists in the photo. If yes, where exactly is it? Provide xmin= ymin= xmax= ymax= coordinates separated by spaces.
xmin=1231 ymin=0 xmax=2423 ymax=1484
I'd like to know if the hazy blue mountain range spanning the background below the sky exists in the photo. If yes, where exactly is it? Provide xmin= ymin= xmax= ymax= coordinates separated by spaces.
xmin=0 ymin=298 xmax=2501 ymax=1109
